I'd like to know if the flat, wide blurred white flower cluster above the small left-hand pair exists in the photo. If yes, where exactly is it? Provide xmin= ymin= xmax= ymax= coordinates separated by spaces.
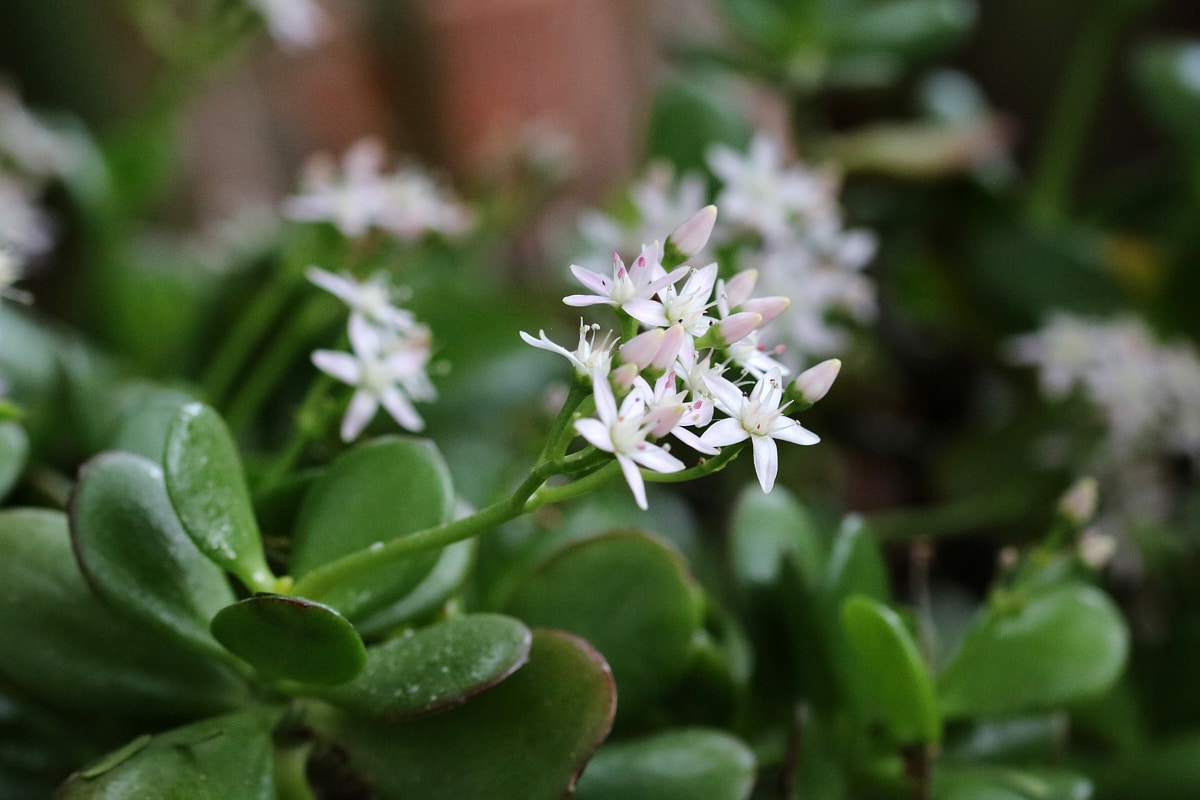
xmin=283 ymin=137 xmax=472 ymax=241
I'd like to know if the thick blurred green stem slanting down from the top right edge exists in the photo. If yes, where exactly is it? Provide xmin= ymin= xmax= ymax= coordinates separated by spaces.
xmin=1028 ymin=2 xmax=1138 ymax=223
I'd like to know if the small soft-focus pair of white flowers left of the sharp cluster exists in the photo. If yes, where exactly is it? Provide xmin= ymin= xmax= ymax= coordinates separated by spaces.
xmin=307 ymin=266 xmax=437 ymax=441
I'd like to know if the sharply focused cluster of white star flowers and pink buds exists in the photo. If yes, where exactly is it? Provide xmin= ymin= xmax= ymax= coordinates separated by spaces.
xmin=521 ymin=206 xmax=840 ymax=509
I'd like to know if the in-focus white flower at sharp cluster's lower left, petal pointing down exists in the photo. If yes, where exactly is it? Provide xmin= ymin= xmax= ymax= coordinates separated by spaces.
xmin=575 ymin=373 xmax=684 ymax=511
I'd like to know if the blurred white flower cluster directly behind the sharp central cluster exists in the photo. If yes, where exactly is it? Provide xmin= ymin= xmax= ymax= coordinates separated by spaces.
xmin=580 ymin=133 xmax=876 ymax=365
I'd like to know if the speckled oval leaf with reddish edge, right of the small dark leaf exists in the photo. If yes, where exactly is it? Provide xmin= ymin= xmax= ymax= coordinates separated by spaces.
xmin=319 ymin=614 xmax=532 ymax=718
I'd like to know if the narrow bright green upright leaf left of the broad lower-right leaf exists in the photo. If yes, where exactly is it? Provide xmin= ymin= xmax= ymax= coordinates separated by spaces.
xmin=841 ymin=595 xmax=942 ymax=745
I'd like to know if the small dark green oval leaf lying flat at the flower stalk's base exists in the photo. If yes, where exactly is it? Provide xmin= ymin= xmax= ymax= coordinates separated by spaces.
xmin=212 ymin=594 xmax=367 ymax=686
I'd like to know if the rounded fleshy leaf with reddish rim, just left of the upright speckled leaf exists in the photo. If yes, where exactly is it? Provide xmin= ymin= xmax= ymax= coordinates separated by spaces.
xmin=70 ymin=452 xmax=234 ymax=657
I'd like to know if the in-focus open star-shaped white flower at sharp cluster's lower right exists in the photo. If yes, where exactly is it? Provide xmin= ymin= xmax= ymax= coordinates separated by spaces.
xmin=701 ymin=371 xmax=821 ymax=492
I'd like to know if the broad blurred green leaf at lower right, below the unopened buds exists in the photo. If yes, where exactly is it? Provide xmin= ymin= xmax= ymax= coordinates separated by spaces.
xmin=938 ymin=585 xmax=1129 ymax=717
